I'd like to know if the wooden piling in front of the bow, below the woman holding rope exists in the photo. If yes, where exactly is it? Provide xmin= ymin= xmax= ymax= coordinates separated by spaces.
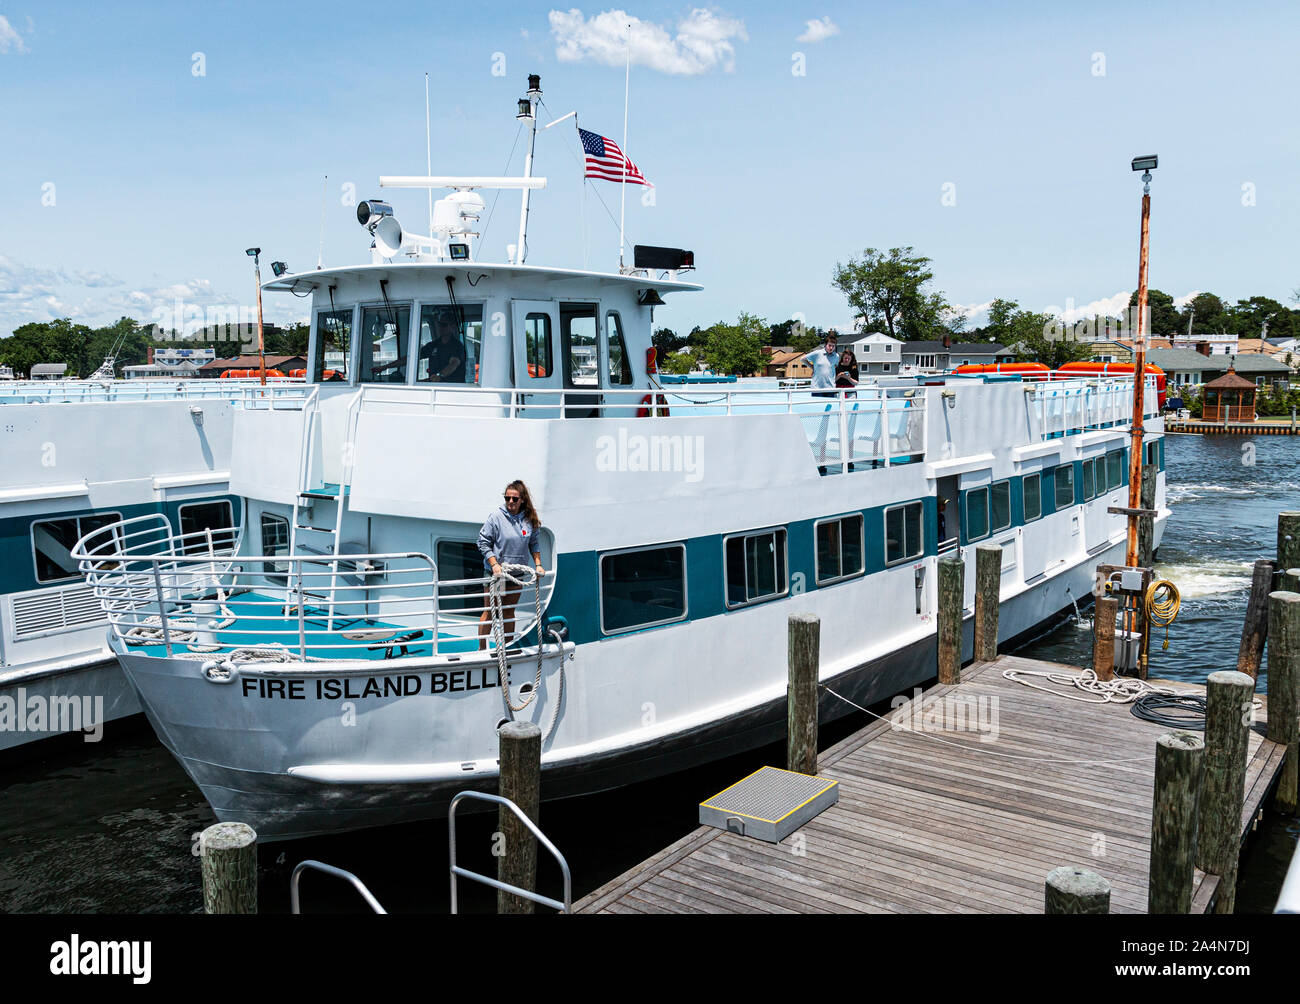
xmin=497 ymin=722 xmax=542 ymax=913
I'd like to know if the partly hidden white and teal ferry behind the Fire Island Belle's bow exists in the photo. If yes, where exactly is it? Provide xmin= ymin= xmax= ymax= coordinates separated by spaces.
xmin=0 ymin=380 xmax=307 ymax=750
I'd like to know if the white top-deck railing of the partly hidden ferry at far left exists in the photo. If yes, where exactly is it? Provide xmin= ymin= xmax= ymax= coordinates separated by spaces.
xmin=0 ymin=377 xmax=316 ymax=404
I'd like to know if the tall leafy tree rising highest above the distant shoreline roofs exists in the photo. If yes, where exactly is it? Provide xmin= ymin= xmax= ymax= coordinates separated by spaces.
xmin=831 ymin=247 xmax=952 ymax=339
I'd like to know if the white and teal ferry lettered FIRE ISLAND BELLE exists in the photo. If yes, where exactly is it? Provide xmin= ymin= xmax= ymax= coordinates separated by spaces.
xmin=73 ymin=76 xmax=1169 ymax=840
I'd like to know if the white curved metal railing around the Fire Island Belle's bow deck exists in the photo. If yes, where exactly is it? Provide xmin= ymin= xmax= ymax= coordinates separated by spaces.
xmin=72 ymin=515 xmax=554 ymax=661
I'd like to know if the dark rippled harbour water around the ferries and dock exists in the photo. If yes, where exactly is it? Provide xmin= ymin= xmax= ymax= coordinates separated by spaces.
xmin=0 ymin=436 xmax=1300 ymax=913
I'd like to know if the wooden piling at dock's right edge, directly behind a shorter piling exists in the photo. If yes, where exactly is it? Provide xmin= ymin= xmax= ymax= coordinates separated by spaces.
xmin=1196 ymin=671 xmax=1255 ymax=913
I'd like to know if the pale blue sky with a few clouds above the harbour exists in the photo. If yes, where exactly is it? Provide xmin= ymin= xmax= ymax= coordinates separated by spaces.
xmin=0 ymin=0 xmax=1300 ymax=336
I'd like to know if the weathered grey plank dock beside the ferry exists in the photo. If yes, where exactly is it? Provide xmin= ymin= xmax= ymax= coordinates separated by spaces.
xmin=575 ymin=655 xmax=1286 ymax=913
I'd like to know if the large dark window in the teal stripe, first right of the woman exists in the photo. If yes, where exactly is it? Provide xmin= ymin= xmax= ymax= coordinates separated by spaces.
xmin=601 ymin=544 xmax=686 ymax=635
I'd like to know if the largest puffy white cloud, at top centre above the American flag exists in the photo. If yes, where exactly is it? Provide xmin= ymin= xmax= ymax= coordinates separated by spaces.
xmin=549 ymin=8 xmax=749 ymax=77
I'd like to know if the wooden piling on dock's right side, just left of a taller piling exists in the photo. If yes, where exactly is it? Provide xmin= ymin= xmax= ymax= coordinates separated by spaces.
xmin=1147 ymin=732 xmax=1205 ymax=913
